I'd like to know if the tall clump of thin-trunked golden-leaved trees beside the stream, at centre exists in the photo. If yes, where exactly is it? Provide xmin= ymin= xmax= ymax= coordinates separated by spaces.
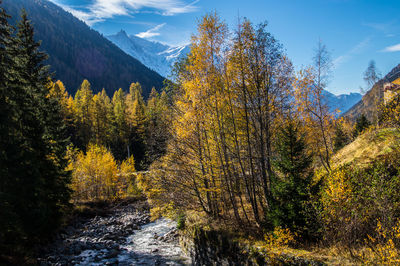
xmin=145 ymin=13 xmax=292 ymax=227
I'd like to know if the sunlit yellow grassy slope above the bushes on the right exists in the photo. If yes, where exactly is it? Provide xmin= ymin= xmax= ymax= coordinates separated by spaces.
xmin=332 ymin=128 xmax=400 ymax=167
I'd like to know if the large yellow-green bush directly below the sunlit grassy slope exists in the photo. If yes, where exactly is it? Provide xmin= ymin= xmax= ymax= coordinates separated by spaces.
xmin=321 ymin=152 xmax=400 ymax=247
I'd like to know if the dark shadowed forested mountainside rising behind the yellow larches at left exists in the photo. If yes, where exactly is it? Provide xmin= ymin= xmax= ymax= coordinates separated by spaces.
xmin=2 ymin=0 xmax=164 ymax=96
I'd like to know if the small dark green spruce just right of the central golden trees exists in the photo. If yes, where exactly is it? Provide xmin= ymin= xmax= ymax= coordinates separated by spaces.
xmin=270 ymin=121 xmax=313 ymax=239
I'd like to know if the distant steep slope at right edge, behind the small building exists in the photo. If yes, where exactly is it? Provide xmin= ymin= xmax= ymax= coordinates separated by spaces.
xmin=343 ymin=64 xmax=400 ymax=121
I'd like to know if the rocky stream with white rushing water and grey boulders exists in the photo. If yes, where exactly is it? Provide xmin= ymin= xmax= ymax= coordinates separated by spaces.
xmin=38 ymin=202 xmax=191 ymax=265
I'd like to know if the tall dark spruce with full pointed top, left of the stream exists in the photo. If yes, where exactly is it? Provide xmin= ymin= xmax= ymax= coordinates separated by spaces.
xmin=1 ymin=8 xmax=70 ymax=251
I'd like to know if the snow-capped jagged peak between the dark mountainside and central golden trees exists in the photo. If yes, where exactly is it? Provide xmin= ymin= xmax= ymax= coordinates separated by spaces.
xmin=106 ymin=30 xmax=190 ymax=77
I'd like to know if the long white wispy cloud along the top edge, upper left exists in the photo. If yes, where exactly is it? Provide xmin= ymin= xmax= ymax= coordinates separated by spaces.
xmin=51 ymin=0 xmax=199 ymax=25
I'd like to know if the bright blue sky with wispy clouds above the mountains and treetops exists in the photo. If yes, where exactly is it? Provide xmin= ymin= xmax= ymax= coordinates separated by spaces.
xmin=51 ymin=0 xmax=400 ymax=94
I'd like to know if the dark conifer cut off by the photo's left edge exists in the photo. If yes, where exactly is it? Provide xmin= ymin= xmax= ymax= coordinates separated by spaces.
xmin=0 ymin=0 xmax=22 ymax=250
